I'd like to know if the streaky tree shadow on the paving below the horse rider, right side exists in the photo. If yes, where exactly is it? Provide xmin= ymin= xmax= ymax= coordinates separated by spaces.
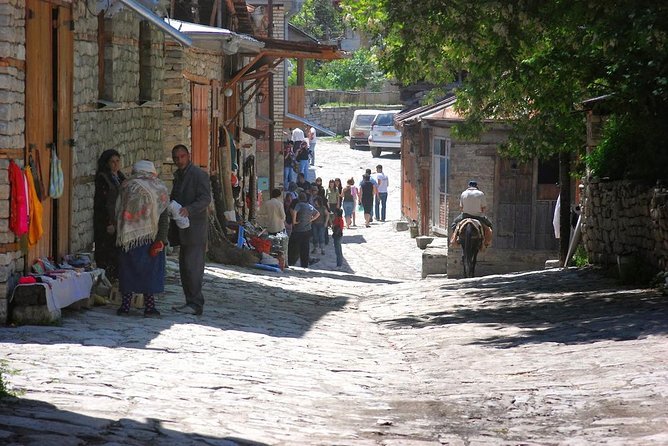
xmin=383 ymin=270 xmax=668 ymax=348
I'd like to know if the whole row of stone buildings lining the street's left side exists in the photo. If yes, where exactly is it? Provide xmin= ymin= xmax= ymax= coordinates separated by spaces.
xmin=0 ymin=0 xmax=340 ymax=322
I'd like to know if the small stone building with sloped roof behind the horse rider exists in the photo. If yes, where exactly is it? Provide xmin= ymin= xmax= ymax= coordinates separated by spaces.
xmin=395 ymin=98 xmax=559 ymax=277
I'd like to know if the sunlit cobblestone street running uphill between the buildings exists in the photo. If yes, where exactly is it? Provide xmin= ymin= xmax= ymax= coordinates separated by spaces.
xmin=0 ymin=141 xmax=668 ymax=446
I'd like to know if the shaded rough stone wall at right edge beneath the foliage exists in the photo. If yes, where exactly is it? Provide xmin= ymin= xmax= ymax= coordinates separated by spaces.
xmin=582 ymin=179 xmax=668 ymax=271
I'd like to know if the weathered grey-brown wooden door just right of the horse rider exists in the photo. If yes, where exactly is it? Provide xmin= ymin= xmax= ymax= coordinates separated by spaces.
xmin=496 ymin=158 xmax=533 ymax=249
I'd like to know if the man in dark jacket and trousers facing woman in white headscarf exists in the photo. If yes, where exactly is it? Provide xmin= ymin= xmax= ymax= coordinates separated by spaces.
xmin=170 ymin=144 xmax=211 ymax=315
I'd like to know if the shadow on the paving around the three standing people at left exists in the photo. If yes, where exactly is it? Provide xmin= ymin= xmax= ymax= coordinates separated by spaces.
xmin=0 ymin=269 xmax=348 ymax=348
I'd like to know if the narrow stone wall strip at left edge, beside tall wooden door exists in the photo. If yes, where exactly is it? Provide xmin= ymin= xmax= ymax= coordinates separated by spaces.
xmin=0 ymin=0 xmax=26 ymax=324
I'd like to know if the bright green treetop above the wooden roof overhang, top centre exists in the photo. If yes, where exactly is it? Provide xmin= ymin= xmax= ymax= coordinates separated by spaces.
xmin=290 ymin=0 xmax=345 ymax=41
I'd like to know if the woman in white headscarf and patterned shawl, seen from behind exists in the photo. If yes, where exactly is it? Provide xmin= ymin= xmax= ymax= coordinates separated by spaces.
xmin=116 ymin=160 xmax=169 ymax=317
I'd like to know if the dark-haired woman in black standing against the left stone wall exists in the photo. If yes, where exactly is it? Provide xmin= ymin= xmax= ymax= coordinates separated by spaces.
xmin=93 ymin=149 xmax=125 ymax=280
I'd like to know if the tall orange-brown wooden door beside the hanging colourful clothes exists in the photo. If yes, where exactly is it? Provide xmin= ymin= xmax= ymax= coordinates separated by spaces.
xmin=25 ymin=0 xmax=73 ymax=269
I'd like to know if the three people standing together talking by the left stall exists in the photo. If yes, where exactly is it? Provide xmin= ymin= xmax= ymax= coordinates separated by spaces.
xmin=93 ymin=144 xmax=211 ymax=317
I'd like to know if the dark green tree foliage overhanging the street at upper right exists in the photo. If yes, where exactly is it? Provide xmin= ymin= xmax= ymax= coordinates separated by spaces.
xmin=341 ymin=0 xmax=668 ymax=176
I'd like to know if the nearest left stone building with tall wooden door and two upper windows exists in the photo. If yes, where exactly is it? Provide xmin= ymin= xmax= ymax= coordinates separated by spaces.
xmin=0 ymin=0 xmax=204 ymax=322
